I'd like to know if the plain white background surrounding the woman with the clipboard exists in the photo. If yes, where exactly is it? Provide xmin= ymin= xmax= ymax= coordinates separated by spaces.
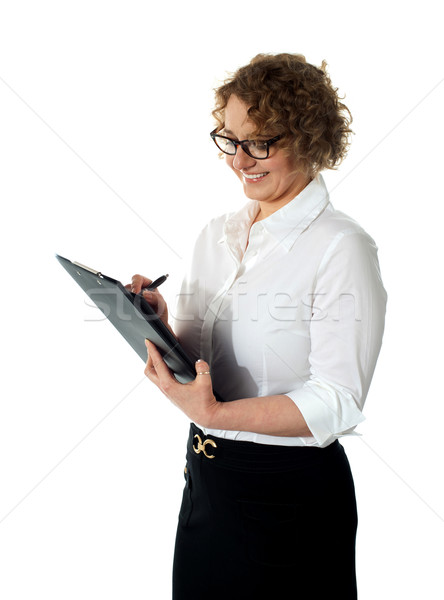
xmin=0 ymin=0 xmax=444 ymax=600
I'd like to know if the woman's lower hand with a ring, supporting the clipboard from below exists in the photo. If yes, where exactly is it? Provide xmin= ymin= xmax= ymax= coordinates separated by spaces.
xmin=145 ymin=340 xmax=220 ymax=427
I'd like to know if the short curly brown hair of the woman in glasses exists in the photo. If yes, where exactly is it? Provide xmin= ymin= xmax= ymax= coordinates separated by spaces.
xmin=212 ymin=53 xmax=353 ymax=177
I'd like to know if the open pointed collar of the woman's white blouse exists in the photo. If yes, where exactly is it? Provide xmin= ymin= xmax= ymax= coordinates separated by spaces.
xmin=219 ymin=174 xmax=329 ymax=251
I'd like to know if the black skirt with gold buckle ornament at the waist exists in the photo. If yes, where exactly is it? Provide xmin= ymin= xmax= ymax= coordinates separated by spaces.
xmin=173 ymin=423 xmax=357 ymax=600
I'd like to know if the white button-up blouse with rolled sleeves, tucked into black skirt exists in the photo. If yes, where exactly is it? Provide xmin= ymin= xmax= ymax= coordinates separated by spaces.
xmin=173 ymin=175 xmax=387 ymax=447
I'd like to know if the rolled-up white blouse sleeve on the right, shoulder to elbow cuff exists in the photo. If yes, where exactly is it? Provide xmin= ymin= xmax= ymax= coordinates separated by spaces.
xmin=285 ymin=230 xmax=387 ymax=447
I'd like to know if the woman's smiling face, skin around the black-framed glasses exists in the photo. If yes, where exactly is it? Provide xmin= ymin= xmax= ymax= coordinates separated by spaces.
xmin=222 ymin=94 xmax=310 ymax=218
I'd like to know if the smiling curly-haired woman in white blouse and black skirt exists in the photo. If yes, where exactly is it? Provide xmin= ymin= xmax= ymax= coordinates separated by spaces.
xmin=132 ymin=54 xmax=386 ymax=600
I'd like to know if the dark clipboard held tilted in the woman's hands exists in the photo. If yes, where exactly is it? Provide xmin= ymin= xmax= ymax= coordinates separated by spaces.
xmin=56 ymin=254 xmax=196 ymax=383
